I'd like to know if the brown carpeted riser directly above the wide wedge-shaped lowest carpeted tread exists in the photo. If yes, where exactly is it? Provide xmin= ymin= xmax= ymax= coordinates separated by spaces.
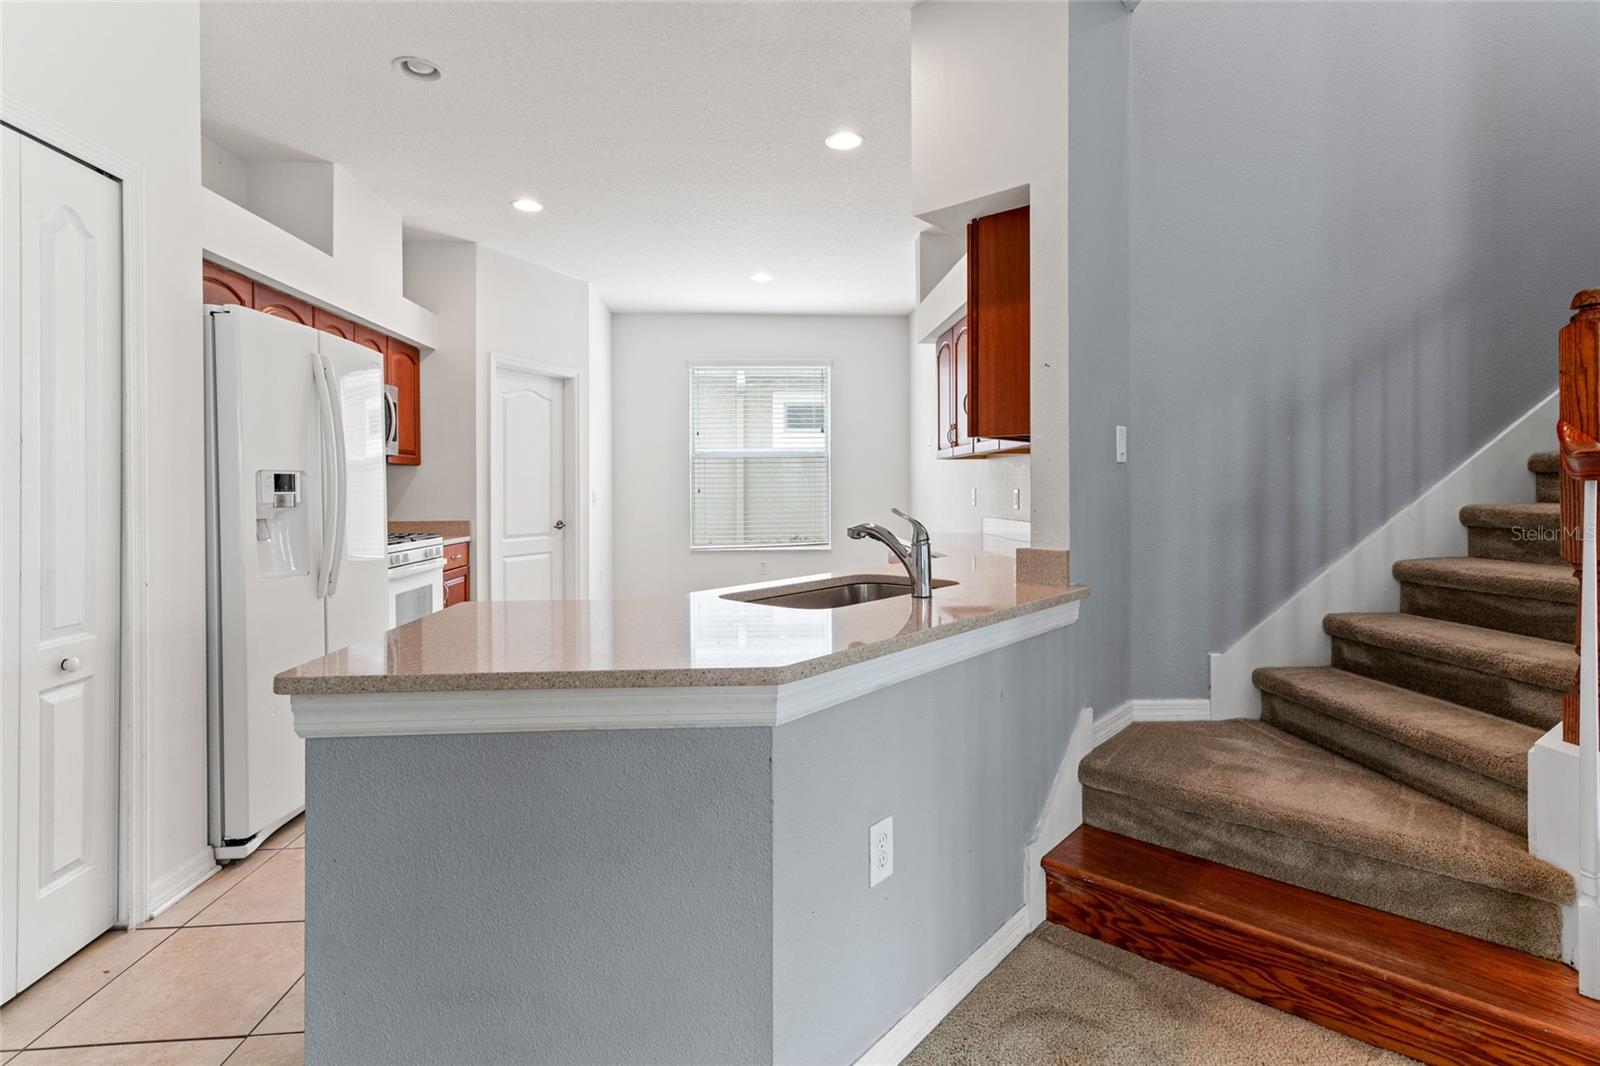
xmin=1261 ymin=691 xmax=1528 ymax=836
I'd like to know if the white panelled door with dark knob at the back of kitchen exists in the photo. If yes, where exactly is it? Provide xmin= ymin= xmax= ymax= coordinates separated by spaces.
xmin=490 ymin=363 xmax=568 ymax=600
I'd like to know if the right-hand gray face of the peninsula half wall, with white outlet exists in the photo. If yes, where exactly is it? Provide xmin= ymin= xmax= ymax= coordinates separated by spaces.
xmin=773 ymin=626 xmax=1075 ymax=1063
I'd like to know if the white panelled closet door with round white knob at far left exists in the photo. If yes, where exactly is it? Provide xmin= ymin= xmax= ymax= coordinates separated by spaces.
xmin=0 ymin=130 xmax=122 ymax=991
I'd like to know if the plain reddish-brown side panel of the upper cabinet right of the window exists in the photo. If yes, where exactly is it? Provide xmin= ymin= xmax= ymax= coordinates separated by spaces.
xmin=957 ymin=206 xmax=1030 ymax=440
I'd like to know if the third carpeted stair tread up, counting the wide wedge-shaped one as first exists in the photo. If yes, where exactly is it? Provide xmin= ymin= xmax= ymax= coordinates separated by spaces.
xmin=1322 ymin=611 xmax=1578 ymax=691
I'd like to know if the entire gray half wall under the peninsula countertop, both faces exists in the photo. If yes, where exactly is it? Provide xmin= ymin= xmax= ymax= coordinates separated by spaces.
xmin=306 ymin=629 xmax=1075 ymax=1066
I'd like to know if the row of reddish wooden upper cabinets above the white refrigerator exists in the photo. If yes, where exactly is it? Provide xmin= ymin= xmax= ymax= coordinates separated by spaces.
xmin=200 ymin=259 xmax=422 ymax=466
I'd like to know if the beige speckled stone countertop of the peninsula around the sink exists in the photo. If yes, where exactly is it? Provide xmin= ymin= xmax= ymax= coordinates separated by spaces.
xmin=274 ymin=538 xmax=1088 ymax=696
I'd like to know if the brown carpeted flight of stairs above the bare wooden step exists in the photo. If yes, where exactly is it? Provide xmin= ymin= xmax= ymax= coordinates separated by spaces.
xmin=1078 ymin=453 xmax=1578 ymax=959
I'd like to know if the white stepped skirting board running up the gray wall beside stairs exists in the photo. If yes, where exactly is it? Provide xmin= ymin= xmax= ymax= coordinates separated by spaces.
xmin=1211 ymin=392 xmax=1557 ymax=719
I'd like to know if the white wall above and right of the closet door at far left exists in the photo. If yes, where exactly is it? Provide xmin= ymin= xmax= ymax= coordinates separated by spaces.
xmin=0 ymin=3 xmax=210 ymax=915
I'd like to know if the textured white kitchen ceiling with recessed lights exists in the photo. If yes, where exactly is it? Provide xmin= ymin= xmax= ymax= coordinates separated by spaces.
xmin=202 ymin=3 xmax=917 ymax=312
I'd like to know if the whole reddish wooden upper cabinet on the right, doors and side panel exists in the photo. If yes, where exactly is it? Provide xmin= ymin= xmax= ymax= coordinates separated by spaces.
xmin=934 ymin=206 xmax=1030 ymax=459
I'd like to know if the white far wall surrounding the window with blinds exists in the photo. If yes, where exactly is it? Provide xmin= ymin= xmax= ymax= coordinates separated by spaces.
xmin=611 ymin=314 xmax=915 ymax=599
